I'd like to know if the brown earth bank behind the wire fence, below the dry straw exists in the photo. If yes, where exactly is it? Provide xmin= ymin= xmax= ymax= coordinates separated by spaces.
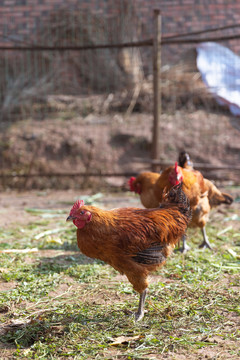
xmin=0 ymin=109 xmax=240 ymax=191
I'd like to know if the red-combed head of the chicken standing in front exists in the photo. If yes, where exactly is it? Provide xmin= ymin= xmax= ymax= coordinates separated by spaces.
xmin=66 ymin=200 xmax=92 ymax=229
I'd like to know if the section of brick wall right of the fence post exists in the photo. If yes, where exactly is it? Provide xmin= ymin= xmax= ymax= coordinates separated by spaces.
xmin=158 ymin=0 xmax=240 ymax=61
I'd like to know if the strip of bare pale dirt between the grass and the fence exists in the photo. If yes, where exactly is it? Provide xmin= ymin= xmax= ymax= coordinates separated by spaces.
xmin=0 ymin=186 xmax=240 ymax=228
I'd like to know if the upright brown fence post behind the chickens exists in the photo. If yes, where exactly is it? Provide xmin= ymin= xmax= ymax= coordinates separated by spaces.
xmin=151 ymin=10 xmax=161 ymax=171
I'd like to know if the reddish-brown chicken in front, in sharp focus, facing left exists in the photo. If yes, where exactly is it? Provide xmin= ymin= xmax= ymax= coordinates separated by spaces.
xmin=67 ymin=185 xmax=191 ymax=321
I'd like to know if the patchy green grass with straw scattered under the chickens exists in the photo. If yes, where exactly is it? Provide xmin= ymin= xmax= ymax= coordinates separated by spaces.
xmin=0 ymin=197 xmax=240 ymax=359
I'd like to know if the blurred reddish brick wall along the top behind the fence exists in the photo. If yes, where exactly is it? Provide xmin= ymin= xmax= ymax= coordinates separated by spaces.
xmin=0 ymin=0 xmax=240 ymax=62
